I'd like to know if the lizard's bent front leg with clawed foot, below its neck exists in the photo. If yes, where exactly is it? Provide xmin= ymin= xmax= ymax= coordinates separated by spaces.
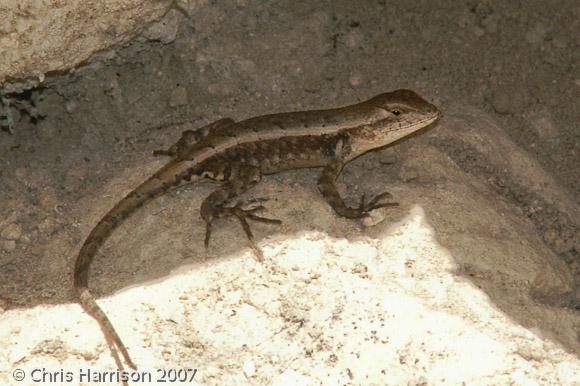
xmin=318 ymin=158 xmax=399 ymax=218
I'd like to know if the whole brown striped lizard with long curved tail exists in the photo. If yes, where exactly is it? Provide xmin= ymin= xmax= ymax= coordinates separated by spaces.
xmin=73 ymin=89 xmax=440 ymax=370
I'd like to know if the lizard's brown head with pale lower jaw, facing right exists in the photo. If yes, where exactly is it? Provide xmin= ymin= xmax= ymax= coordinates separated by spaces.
xmin=350 ymin=90 xmax=441 ymax=157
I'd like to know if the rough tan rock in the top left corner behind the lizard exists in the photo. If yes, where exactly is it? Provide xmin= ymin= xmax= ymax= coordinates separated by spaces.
xmin=0 ymin=0 xmax=171 ymax=91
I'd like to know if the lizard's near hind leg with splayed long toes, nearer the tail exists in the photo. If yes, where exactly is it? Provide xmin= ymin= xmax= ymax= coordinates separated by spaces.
xmin=200 ymin=165 xmax=281 ymax=261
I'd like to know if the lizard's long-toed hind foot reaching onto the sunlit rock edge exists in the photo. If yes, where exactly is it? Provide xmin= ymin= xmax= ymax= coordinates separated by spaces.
xmin=204 ymin=198 xmax=282 ymax=261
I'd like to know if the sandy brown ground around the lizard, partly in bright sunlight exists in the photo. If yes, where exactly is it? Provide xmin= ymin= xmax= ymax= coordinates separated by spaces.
xmin=0 ymin=1 xmax=580 ymax=385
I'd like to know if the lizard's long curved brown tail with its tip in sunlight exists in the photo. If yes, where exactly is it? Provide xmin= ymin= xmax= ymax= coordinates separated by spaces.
xmin=73 ymin=164 xmax=199 ymax=370
